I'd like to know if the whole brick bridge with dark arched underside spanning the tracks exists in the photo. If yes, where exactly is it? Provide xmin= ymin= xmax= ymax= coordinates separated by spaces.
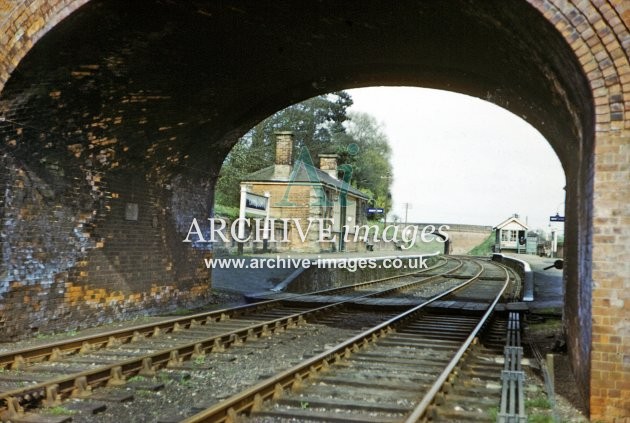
xmin=0 ymin=0 xmax=630 ymax=421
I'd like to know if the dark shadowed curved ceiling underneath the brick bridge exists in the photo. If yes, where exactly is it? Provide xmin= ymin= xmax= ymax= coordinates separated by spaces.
xmin=0 ymin=0 xmax=591 ymax=175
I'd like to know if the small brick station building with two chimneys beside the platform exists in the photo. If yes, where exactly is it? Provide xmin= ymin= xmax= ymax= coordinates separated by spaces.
xmin=241 ymin=132 xmax=368 ymax=252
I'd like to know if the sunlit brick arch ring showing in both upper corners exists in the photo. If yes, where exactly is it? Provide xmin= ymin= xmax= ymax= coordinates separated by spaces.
xmin=0 ymin=0 xmax=630 ymax=141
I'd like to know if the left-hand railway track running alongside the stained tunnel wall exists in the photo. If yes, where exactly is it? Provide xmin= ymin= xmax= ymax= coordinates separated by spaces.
xmin=0 ymin=259 xmax=494 ymax=420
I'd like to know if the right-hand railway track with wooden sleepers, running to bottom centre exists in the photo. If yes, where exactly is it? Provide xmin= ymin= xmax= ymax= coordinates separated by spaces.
xmin=178 ymin=265 xmax=510 ymax=423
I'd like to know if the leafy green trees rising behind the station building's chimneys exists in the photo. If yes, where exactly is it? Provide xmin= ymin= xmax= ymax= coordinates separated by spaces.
xmin=216 ymin=91 xmax=392 ymax=219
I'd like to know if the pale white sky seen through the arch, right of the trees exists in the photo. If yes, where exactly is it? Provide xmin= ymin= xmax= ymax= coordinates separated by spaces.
xmin=348 ymin=87 xmax=565 ymax=230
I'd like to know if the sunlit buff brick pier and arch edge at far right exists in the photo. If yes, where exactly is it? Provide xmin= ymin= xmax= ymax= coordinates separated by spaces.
xmin=532 ymin=0 xmax=630 ymax=421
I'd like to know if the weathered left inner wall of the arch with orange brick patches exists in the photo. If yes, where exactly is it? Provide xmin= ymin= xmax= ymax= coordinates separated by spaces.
xmin=0 ymin=11 xmax=222 ymax=340
